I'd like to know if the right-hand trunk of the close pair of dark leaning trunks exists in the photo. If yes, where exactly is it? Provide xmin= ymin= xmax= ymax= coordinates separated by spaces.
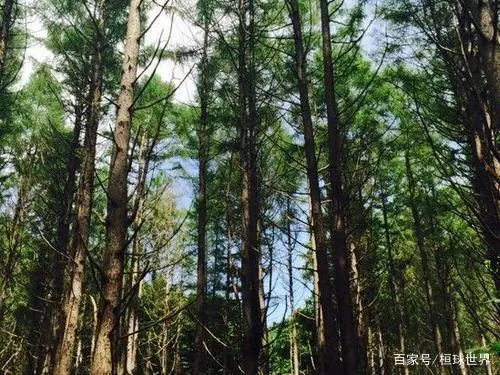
xmin=320 ymin=0 xmax=358 ymax=375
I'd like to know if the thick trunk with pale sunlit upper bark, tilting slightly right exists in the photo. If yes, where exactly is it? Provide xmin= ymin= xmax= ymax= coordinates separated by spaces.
xmin=91 ymin=0 xmax=141 ymax=375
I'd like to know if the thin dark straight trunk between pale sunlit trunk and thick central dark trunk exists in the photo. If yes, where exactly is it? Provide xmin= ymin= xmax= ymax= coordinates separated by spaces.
xmin=193 ymin=15 xmax=208 ymax=374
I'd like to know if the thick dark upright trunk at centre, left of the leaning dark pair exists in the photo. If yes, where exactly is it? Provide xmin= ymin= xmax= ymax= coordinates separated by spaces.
xmin=238 ymin=0 xmax=263 ymax=375
